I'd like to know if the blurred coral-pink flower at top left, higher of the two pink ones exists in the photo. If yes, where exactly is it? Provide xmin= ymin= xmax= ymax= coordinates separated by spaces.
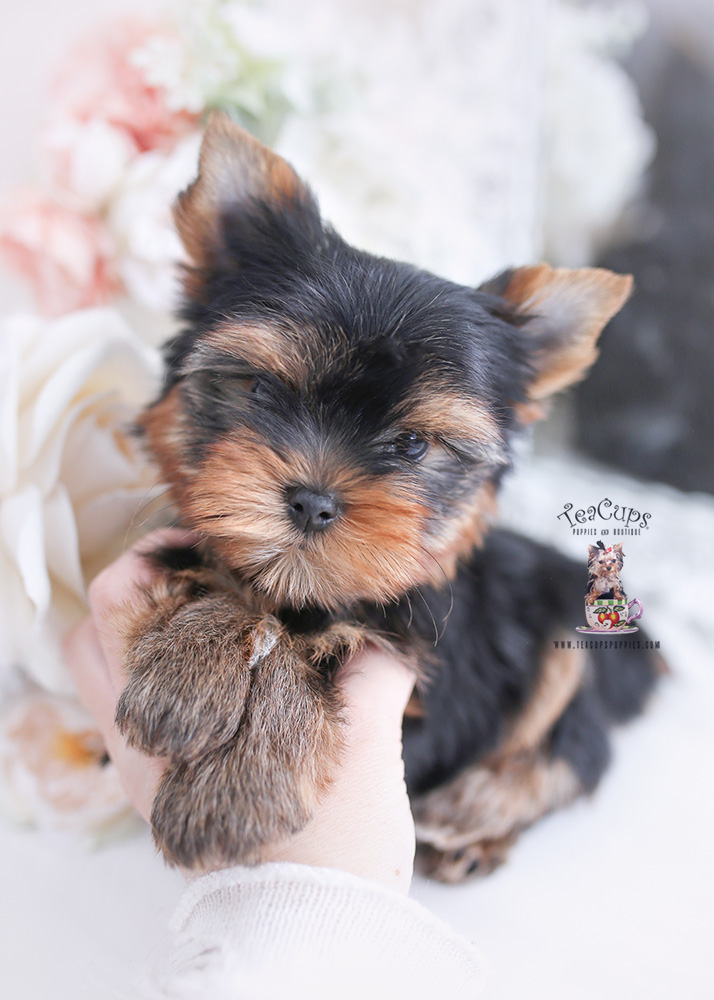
xmin=49 ymin=20 xmax=197 ymax=152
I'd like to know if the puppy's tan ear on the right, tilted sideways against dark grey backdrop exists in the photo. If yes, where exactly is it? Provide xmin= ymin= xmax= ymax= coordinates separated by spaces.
xmin=483 ymin=264 xmax=632 ymax=403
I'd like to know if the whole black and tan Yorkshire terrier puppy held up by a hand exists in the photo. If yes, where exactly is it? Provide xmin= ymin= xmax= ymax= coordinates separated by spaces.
xmin=117 ymin=115 xmax=655 ymax=880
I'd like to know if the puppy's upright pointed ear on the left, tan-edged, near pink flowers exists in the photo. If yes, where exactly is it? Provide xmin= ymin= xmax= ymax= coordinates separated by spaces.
xmin=173 ymin=111 xmax=319 ymax=267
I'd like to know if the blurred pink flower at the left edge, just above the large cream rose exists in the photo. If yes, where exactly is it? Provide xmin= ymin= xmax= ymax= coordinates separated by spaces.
xmin=0 ymin=190 xmax=121 ymax=316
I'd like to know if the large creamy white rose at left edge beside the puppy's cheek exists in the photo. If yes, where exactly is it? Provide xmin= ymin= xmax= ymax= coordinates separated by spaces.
xmin=0 ymin=309 xmax=159 ymax=690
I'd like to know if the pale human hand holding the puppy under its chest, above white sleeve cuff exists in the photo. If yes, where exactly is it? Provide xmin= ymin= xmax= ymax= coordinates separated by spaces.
xmin=65 ymin=531 xmax=415 ymax=892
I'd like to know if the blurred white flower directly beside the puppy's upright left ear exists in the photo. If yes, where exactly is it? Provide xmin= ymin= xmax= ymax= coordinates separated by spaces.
xmin=107 ymin=133 xmax=201 ymax=312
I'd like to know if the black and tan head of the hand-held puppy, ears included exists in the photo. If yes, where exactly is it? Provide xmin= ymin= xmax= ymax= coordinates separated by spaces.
xmin=142 ymin=116 xmax=630 ymax=609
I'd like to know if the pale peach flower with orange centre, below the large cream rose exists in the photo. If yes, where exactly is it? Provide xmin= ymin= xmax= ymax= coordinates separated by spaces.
xmin=0 ymin=688 xmax=132 ymax=832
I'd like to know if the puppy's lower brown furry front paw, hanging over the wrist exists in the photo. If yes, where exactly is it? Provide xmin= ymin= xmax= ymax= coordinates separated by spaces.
xmin=151 ymin=643 xmax=342 ymax=869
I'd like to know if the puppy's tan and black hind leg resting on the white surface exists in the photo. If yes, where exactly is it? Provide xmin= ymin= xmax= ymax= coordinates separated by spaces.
xmin=414 ymin=650 xmax=610 ymax=882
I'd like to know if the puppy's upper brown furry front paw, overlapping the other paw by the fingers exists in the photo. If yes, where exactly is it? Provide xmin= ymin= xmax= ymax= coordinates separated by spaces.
xmin=116 ymin=594 xmax=279 ymax=760
